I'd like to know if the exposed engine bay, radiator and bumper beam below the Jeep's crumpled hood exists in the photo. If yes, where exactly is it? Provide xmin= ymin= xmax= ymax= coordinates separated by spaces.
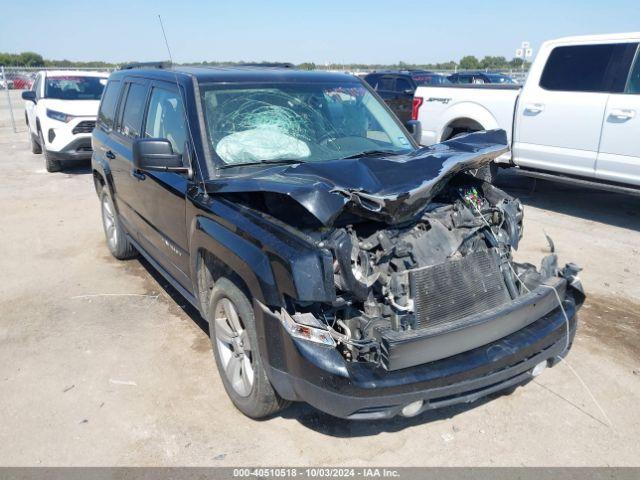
xmin=282 ymin=173 xmax=580 ymax=370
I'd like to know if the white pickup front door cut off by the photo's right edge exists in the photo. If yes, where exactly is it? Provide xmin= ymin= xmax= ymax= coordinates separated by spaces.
xmin=596 ymin=43 xmax=640 ymax=185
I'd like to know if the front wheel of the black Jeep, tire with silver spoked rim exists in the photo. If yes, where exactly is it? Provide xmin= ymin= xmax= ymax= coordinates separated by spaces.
xmin=207 ymin=278 xmax=289 ymax=419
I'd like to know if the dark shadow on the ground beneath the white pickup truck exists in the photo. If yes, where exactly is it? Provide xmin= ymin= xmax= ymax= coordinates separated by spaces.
xmin=495 ymin=170 xmax=640 ymax=231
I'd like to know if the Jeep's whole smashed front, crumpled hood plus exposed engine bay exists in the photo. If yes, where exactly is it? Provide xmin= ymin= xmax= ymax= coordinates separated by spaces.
xmin=211 ymin=131 xmax=584 ymax=390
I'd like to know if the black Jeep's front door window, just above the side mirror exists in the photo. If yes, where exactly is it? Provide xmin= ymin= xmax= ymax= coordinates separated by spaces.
xmin=144 ymin=87 xmax=187 ymax=154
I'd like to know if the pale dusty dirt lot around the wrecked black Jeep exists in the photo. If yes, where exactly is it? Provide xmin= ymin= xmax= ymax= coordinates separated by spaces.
xmin=0 ymin=92 xmax=640 ymax=466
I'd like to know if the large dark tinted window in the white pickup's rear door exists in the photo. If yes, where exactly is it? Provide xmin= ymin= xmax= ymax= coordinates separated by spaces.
xmin=540 ymin=43 xmax=637 ymax=92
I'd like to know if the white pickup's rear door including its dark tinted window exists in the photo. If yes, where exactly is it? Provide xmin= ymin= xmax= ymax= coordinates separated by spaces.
xmin=514 ymin=43 xmax=630 ymax=177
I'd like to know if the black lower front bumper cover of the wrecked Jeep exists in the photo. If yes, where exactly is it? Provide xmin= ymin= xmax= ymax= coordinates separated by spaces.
xmin=255 ymin=282 xmax=583 ymax=419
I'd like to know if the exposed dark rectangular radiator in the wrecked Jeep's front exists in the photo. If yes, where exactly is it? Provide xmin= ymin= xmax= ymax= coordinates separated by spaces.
xmin=409 ymin=250 xmax=510 ymax=328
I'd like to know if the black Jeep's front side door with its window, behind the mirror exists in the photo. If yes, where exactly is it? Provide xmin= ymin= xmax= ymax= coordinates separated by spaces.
xmin=135 ymin=82 xmax=193 ymax=291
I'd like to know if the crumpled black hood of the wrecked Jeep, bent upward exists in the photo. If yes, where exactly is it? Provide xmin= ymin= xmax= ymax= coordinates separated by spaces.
xmin=207 ymin=130 xmax=508 ymax=226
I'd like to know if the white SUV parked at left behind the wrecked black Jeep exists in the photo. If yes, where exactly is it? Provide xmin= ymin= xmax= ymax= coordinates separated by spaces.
xmin=22 ymin=71 xmax=109 ymax=172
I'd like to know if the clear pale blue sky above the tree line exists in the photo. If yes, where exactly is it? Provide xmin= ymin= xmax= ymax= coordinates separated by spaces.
xmin=0 ymin=0 xmax=640 ymax=64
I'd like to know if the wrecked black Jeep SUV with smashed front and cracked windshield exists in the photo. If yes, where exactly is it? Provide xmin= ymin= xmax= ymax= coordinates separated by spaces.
xmin=92 ymin=67 xmax=584 ymax=419
